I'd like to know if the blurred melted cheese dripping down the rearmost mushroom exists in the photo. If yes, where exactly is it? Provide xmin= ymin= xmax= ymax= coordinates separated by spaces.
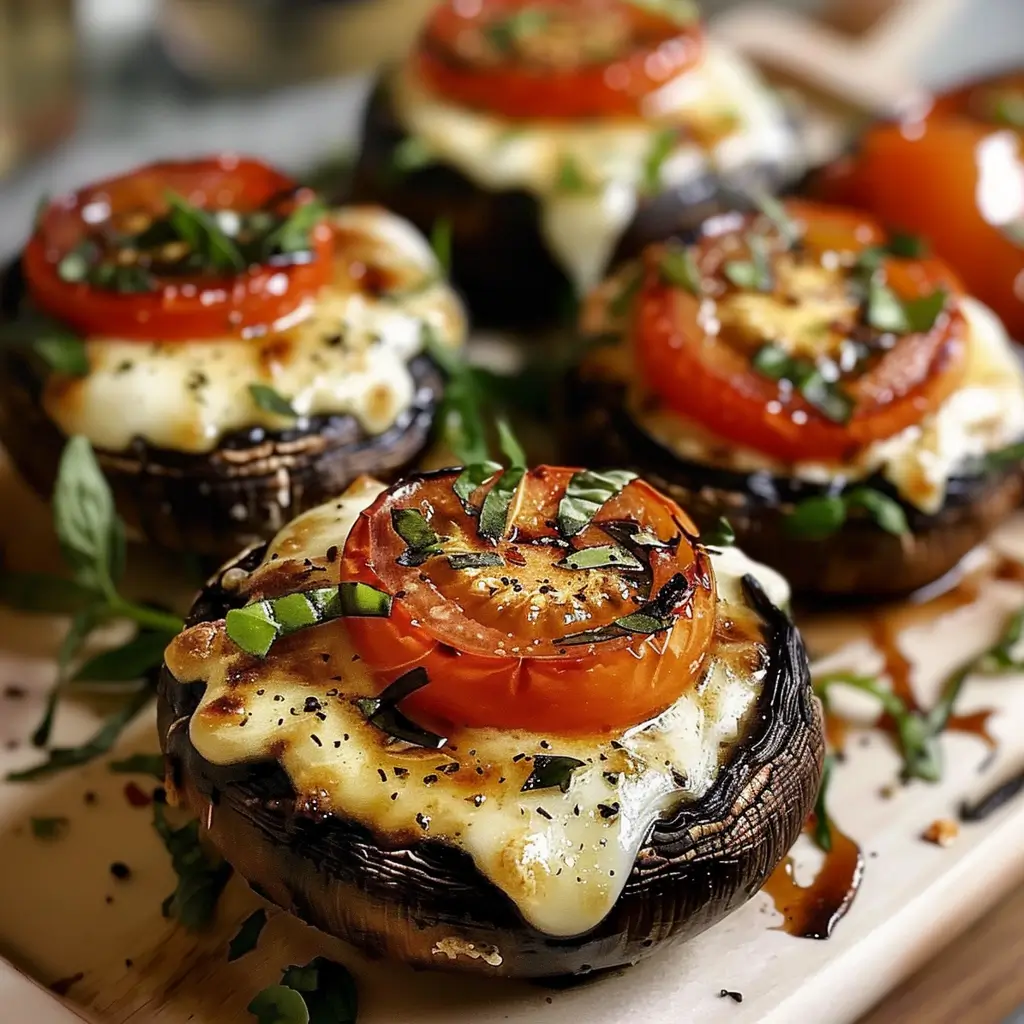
xmin=394 ymin=44 xmax=794 ymax=294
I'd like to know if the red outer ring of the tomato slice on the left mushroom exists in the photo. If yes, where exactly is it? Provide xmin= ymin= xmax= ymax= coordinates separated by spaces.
xmin=23 ymin=156 xmax=334 ymax=341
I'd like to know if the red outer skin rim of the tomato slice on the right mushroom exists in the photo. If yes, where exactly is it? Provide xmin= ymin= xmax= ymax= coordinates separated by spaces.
xmin=632 ymin=194 xmax=966 ymax=464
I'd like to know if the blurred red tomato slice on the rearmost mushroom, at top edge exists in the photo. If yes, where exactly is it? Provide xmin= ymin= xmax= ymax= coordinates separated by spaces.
xmin=415 ymin=0 xmax=703 ymax=119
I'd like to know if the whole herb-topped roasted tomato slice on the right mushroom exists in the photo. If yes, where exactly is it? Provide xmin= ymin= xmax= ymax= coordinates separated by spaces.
xmin=632 ymin=201 xmax=966 ymax=463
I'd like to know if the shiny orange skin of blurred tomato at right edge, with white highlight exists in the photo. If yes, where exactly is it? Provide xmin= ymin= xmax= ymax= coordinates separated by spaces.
xmin=812 ymin=120 xmax=1024 ymax=340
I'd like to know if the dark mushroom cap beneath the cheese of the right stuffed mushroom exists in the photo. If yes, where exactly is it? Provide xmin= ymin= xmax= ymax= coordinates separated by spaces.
xmin=565 ymin=372 xmax=1024 ymax=597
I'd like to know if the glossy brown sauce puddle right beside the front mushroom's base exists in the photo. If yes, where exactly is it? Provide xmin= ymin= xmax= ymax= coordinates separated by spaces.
xmin=763 ymin=822 xmax=864 ymax=939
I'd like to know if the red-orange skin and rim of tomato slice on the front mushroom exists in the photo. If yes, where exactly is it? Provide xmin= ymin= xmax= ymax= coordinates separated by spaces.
xmin=342 ymin=467 xmax=716 ymax=734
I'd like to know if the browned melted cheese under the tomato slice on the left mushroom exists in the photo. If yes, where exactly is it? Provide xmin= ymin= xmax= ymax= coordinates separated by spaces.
xmin=43 ymin=207 xmax=465 ymax=453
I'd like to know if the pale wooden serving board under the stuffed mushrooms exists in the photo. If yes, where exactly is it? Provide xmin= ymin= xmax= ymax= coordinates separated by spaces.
xmin=0 ymin=448 xmax=1024 ymax=1024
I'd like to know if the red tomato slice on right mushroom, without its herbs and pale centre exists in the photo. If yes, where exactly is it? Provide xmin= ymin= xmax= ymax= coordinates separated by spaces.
xmin=632 ymin=201 xmax=966 ymax=463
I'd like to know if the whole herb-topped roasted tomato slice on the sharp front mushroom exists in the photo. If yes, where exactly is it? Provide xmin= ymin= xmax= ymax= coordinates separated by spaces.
xmin=342 ymin=466 xmax=716 ymax=733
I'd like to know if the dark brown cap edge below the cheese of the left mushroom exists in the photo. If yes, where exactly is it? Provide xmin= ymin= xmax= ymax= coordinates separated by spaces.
xmin=0 ymin=261 xmax=443 ymax=557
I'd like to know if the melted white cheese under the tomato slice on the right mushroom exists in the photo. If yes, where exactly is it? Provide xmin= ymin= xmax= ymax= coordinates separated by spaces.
xmin=618 ymin=299 xmax=1024 ymax=513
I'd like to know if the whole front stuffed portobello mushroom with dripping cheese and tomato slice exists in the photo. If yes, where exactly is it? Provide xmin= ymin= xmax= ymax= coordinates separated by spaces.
xmin=160 ymin=465 xmax=822 ymax=977
